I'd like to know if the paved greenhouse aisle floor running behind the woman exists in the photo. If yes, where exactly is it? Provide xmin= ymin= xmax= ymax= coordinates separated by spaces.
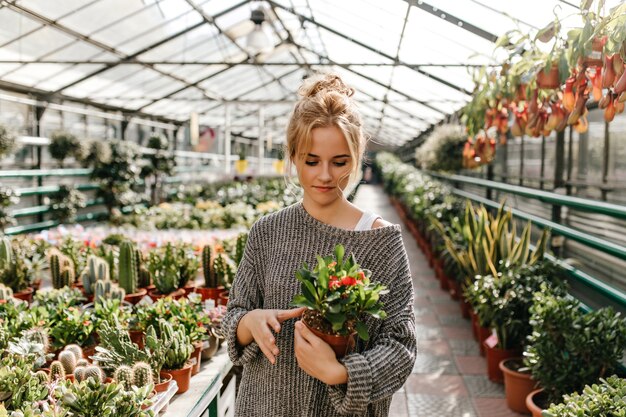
xmin=354 ymin=185 xmax=521 ymax=417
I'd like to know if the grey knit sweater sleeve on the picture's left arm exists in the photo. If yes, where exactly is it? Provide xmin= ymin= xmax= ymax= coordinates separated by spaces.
xmin=222 ymin=224 xmax=263 ymax=366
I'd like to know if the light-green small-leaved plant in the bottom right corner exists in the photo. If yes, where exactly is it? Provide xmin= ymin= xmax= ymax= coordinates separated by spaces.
xmin=543 ymin=375 xmax=626 ymax=417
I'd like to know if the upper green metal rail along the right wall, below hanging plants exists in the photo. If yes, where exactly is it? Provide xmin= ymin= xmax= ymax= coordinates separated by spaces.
xmin=424 ymin=171 xmax=626 ymax=219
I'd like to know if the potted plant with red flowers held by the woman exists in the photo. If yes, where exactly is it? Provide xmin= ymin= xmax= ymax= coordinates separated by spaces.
xmin=292 ymin=245 xmax=389 ymax=357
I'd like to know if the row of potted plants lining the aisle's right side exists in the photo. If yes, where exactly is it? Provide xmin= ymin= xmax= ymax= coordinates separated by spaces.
xmin=377 ymin=154 xmax=626 ymax=416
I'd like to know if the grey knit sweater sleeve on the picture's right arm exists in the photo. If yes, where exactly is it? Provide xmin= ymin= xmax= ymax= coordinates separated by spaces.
xmin=328 ymin=236 xmax=417 ymax=415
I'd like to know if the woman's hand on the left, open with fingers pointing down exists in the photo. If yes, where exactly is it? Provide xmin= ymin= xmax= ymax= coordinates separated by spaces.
xmin=237 ymin=307 xmax=305 ymax=365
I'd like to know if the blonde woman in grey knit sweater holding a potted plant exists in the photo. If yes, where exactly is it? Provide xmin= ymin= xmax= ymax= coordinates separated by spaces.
xmin=222 ymin=75 xmax=416 ymax=417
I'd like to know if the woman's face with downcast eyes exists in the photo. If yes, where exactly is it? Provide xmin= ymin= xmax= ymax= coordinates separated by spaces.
xmin=295 ymin=126 xmax=352 ymax=206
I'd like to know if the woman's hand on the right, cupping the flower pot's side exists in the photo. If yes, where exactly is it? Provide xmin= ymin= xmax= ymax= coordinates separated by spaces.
xmin=294 ymin=321 xmax=348 ymax=385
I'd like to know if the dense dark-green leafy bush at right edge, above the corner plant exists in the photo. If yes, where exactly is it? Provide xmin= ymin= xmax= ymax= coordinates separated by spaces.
xmin=524 ymin=288 xmax=626 ymax=409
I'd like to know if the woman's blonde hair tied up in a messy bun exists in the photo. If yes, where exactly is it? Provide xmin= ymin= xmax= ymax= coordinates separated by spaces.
xmin=286 ymin=74 xmax=366 ymax=187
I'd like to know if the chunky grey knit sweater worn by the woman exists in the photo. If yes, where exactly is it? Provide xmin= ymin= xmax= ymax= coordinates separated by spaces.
xmin=222 ymin=203 xmax=417 ymax=417
